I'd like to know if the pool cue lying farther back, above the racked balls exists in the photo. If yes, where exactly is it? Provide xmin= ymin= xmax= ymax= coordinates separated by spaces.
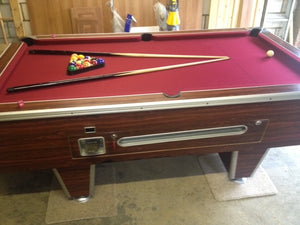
xmin=29 ymin=49 xmax=227 ymax=59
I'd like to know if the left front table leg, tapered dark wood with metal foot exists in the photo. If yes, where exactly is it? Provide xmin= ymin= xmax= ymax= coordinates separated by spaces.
xmin=53 ymin=165 xmax=95 ymax=202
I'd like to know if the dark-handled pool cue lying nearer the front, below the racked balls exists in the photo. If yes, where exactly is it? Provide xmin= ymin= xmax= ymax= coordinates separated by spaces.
xmin=7 ymin=57 xmax=230 ymax=93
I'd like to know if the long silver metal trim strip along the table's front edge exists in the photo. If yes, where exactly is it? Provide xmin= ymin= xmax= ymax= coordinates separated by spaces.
xmin=0 ymin=91 xmax=300 ymax=122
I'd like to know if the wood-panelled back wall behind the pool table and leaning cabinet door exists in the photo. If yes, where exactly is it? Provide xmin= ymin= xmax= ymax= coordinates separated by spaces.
xmin=27 ymin=0 xmax=264 ymax=34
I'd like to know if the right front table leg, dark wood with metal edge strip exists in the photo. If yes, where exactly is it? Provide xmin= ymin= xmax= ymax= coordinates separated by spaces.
xmin=219 ymin=145 xmax=268 ymax=180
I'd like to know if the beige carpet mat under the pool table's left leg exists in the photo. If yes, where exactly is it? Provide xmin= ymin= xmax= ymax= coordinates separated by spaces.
xmin=46 ymin=164 xmax=117 ymax=224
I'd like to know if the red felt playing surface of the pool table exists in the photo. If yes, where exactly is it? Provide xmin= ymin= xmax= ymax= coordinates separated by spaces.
xmin=0 ymin=31 xmax=300 ymax=102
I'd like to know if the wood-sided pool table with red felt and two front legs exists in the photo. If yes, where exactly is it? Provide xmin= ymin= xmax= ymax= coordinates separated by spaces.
xmin=0 ymin=29 xmax=300 ymax=199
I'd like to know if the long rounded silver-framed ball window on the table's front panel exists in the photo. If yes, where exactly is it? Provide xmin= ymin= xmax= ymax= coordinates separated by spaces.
xmin=117 ymin=125 xmax=248 ymax=147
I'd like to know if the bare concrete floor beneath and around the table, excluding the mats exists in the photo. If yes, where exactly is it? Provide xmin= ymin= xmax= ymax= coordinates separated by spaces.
xmin=0 ymin=147 xmax=300 ymax=225
